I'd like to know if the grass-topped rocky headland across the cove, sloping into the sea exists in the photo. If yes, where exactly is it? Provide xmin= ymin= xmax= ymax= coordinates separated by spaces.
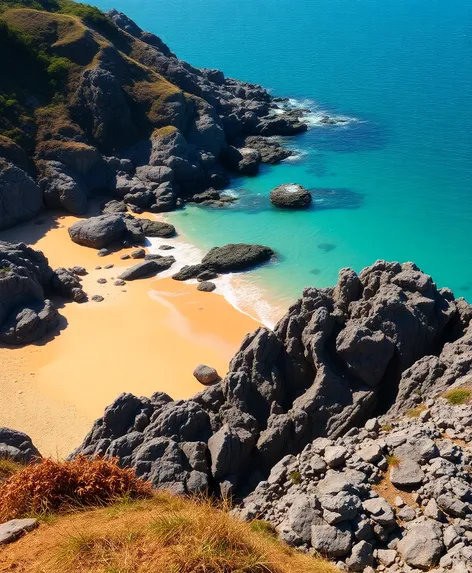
xmin=0 ymin=0 xmax=307 ymax=229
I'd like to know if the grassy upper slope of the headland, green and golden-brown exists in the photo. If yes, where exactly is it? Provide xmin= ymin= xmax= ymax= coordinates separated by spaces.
xmin=0 ymin=0 xmax=194 ymax=155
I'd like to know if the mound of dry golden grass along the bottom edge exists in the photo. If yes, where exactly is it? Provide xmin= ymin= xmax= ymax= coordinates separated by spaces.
xmin=0 ymin=492 xmax=337 ymax=573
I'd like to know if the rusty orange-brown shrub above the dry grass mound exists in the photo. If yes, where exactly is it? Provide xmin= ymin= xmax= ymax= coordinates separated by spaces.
xmin=0 ymin=457 xmax=151 ymax=522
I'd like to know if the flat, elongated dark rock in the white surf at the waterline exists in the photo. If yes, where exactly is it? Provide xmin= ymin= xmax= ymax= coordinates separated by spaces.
xmin=202 ymin=243 xmax=274 ymax=273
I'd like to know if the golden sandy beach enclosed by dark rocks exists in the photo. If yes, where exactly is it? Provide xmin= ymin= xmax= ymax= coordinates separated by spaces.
xmin=0 ymin=214 xmax=259 ymax=457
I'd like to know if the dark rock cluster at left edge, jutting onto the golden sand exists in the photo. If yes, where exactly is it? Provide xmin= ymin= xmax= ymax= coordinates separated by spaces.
xmin=0 ymin=241 xmax=86 ymax=345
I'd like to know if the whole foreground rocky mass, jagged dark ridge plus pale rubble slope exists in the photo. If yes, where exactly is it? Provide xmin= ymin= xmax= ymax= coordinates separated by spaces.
xmin=25 ymin=261 xmax=464 ymax=572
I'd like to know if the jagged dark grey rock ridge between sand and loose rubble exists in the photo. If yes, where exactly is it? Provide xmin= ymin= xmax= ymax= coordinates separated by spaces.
xmin=76 ymin=261 xmax=470 ymax=495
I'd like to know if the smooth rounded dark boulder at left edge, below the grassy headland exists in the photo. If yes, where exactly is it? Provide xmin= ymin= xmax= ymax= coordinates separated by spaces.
xmin=0 ymin=158 xmax=43 ymax=230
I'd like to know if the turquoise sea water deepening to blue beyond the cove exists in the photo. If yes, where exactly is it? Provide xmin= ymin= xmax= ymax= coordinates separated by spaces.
xmin=95 ymin=0 xmax=472 ymax=312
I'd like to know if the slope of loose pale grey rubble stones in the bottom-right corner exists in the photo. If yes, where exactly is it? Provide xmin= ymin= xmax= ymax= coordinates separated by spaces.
xmin=234 ymin=398 xmax=472 ymax=573
